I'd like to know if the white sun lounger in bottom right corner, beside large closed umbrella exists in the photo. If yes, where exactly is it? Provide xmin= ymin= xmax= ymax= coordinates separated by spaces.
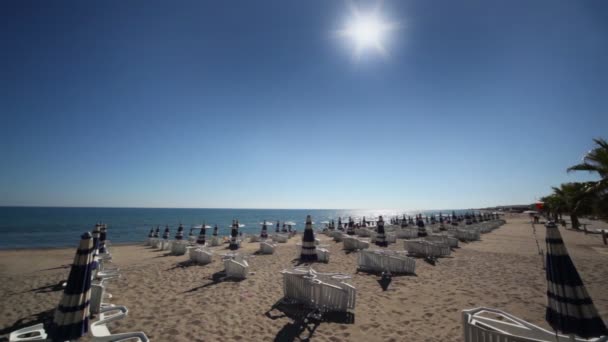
xmin=462 ymin=308 xmax=608 ymax=342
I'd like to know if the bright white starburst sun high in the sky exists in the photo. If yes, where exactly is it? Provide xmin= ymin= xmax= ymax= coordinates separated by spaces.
xmin=337 ymin=3 xmax=398 ymax=57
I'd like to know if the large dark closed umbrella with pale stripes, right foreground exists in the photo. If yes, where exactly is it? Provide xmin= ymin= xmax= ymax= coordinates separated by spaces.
xmin=545 ymin=221 xmax=608 ymax=338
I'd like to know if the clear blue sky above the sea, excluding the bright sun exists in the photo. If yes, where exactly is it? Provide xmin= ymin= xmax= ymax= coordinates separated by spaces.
xmin=0 ymin=0 xmax=608 ymax=209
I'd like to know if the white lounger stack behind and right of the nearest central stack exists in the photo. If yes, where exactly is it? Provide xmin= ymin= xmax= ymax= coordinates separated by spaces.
xmin=357 ymin=249 xmax=416 ymax=274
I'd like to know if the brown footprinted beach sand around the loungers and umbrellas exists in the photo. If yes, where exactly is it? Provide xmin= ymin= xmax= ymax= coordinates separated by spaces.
xmin=0 ymin=215 xmax=608 ymax=341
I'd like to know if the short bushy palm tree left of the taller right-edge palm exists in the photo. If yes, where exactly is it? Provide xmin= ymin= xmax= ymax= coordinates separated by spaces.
xmin=551 ymin=182 xmax=596 ymax=229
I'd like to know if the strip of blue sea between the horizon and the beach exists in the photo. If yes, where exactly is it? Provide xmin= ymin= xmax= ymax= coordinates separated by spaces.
xmin=0 ymin=207 xmax=467 ymax=249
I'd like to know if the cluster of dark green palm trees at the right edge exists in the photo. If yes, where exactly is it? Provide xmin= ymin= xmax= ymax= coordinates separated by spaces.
xmin=541 ymin=139 xmax=608 ymax=229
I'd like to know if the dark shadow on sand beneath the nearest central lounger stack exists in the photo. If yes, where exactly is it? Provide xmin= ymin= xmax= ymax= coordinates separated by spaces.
xmin=264 ymin=299 xmax=355 ymax=341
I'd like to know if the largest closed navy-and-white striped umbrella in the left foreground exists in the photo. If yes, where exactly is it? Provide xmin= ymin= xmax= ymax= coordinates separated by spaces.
xmin=49 ymin=232 xmax=94 ymax=341
